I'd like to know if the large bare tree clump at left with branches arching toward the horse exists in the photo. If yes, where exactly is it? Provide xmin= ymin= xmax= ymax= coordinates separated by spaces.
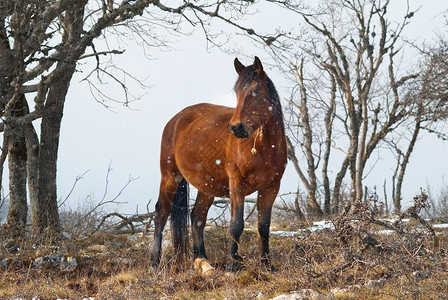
xmin=0 ymin=0 xmax=260 ymax=237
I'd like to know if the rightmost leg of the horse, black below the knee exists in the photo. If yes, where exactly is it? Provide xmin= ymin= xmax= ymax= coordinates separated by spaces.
xmin=257 ymin=187 xmax=279 ymax=268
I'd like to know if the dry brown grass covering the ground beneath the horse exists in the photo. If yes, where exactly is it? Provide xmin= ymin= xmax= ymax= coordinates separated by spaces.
xmin=0 ymin=224 xmax=448 ymax=299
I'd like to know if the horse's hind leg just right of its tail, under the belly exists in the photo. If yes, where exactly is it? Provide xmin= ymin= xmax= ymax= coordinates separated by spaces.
xmin=191 ymin=191 xmax=214 ymax=259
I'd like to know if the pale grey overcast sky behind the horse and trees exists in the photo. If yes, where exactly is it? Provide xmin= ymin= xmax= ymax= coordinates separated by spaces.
xmin=19 ymin=0 xmax=448 ymax=217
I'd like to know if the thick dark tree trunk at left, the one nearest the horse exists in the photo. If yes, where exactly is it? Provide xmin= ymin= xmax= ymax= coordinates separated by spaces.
xmin=30 ymin=0 xmax=87 ymax=240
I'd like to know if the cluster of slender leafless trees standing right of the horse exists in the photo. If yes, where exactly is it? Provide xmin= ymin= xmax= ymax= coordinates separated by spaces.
xmin=256 ymin=0 xmax=438 ymax=215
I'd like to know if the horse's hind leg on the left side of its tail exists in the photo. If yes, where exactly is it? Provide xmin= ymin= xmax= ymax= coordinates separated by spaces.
xmin=151 ymin=176 xmax=179 ymax=266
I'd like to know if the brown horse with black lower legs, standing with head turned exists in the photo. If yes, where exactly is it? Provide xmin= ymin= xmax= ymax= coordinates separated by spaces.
xmin=152 ymin=57 xmax=287 ymax=270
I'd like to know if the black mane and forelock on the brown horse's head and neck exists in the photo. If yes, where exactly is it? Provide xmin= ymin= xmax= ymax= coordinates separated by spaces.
xmin=234 ymin=66 xmax=283 ymax=118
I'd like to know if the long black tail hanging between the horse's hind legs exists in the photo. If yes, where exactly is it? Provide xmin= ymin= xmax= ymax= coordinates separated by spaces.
xmin=170 ymin=179 xmax=189 ymax=259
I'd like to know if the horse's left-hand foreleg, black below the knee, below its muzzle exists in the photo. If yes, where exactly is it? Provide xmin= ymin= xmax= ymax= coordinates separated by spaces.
xmin=228 ymin=190 xmax=244 ymax=271
